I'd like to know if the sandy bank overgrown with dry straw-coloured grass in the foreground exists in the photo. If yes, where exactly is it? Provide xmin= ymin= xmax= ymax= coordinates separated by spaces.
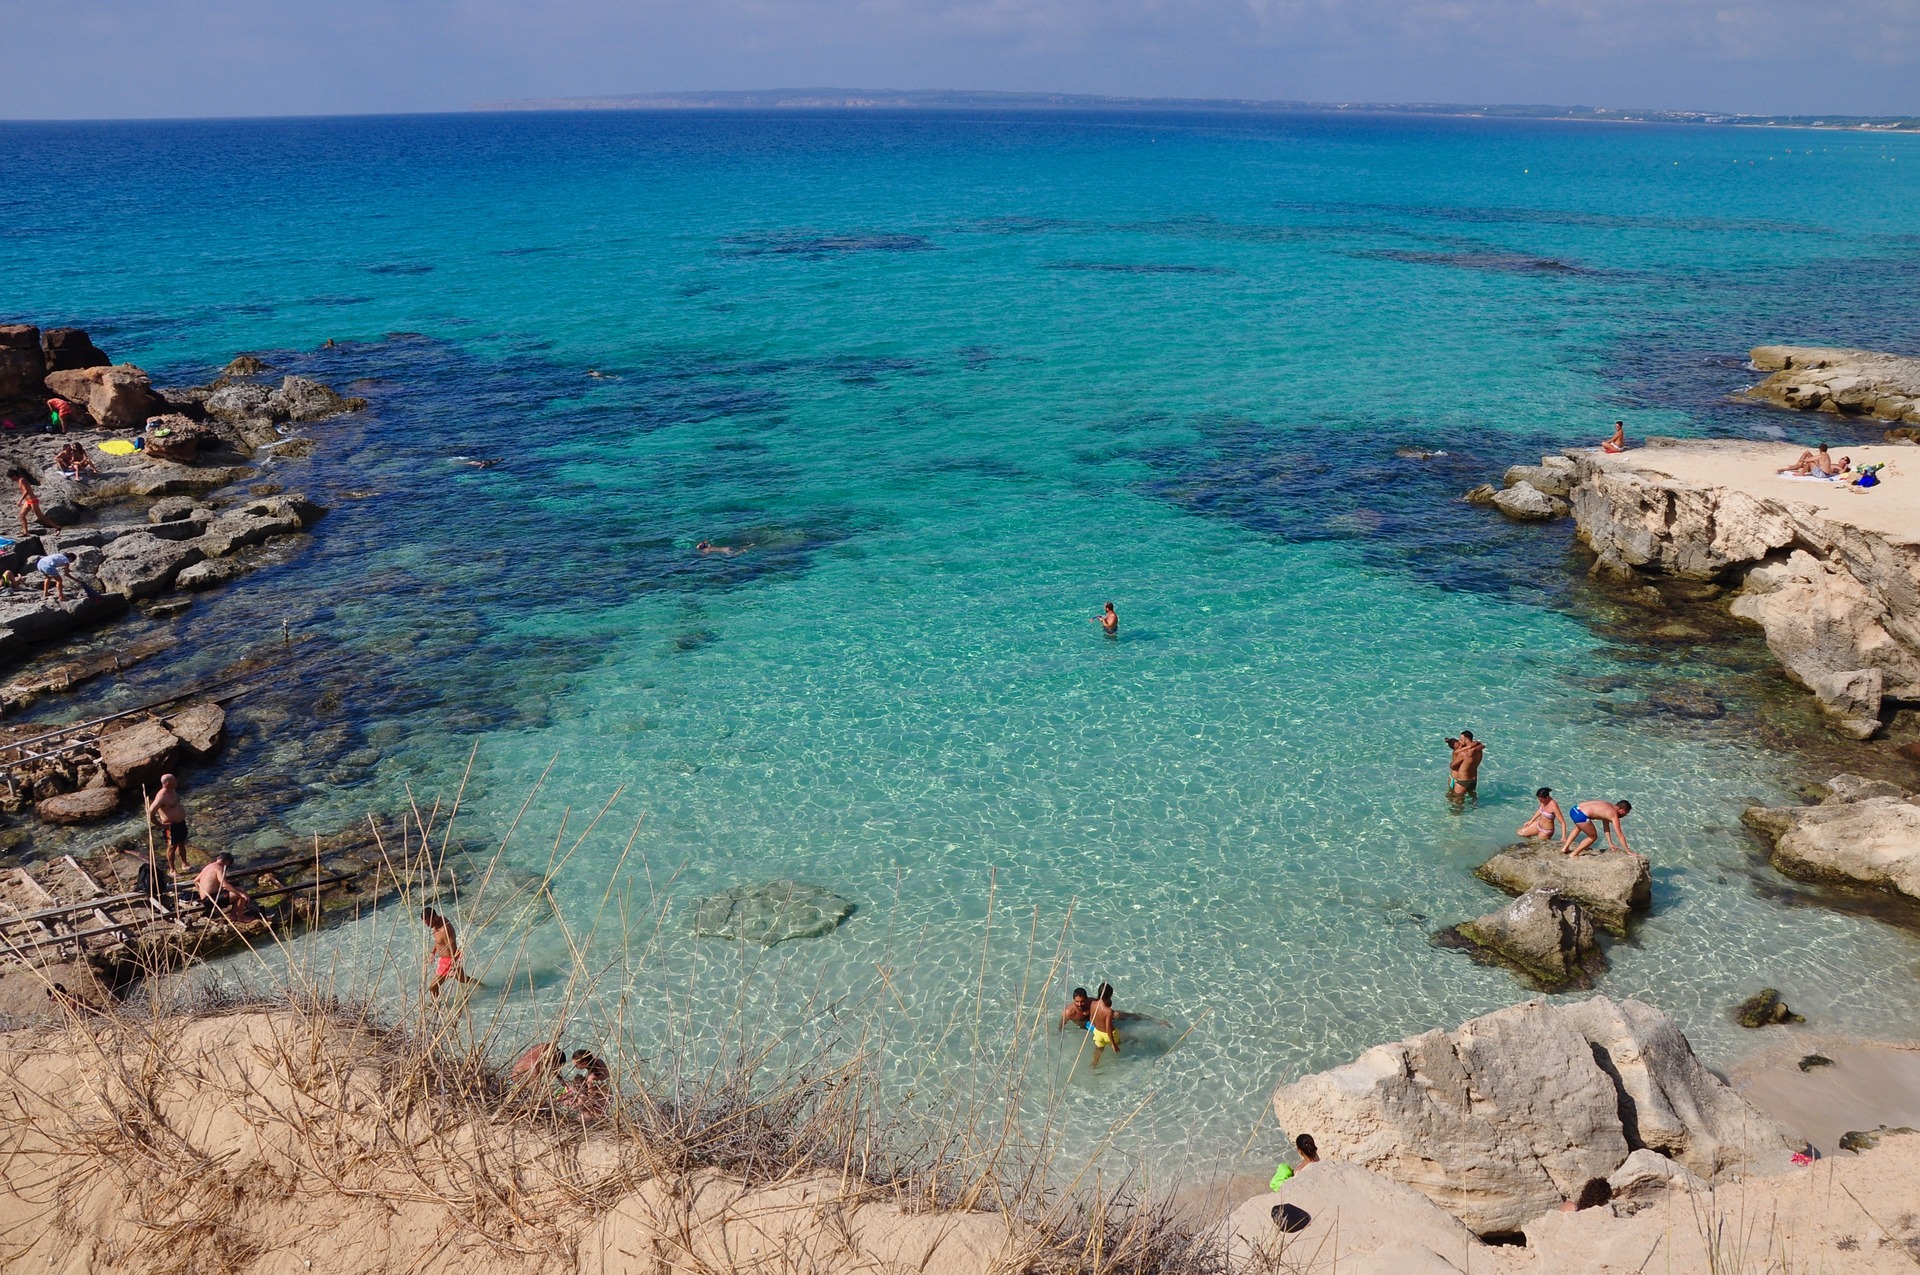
xmin=0 ymin=760 xmax=1225 ymax=1275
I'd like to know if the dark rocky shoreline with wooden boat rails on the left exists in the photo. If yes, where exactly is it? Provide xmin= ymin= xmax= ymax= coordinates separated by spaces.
xmin=0 ymin=325 xmax=410 ymax=1016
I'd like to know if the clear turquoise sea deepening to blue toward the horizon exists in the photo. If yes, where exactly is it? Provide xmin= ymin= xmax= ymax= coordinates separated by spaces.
xmin=0 ymin=113 xmax=1920 ymax=1171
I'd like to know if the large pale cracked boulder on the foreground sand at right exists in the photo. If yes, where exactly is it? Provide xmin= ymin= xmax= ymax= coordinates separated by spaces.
xmin=1273 ymin=997 xmax=1791 ymax=1237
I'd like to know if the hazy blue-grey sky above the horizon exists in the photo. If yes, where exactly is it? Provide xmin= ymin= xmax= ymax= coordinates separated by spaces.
xmin=0 ymin=0 xmax=1920 ymax=119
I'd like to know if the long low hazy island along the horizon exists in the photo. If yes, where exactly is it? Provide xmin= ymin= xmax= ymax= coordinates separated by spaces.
xmin=474 ymin=88 xmax=1920 ymax=132
